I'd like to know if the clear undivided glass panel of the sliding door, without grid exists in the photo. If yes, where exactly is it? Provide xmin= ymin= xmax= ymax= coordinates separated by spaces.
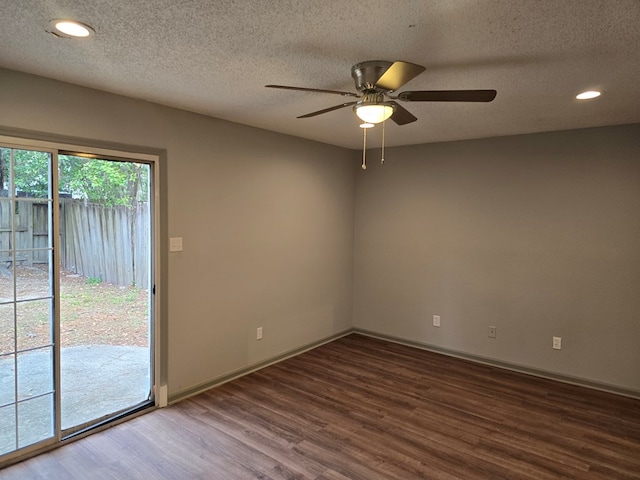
xmin=59 ymin=155 xmax=151 ymax=435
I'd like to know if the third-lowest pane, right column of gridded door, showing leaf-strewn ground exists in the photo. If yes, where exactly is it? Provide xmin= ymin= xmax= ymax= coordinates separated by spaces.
xmin=16 ymin=300 xmax=52 ymax=351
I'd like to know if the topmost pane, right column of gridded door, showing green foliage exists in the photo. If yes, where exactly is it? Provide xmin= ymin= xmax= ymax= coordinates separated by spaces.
xmin=13 ymin=150 xmax=50 ymax=198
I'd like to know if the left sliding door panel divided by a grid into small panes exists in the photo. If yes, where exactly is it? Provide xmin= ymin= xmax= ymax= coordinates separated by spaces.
xmin=0 ymin=148 xmax=55 ymax=454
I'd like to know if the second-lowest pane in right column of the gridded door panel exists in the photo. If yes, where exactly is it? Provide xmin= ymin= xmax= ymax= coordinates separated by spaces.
xmin=17 ymin=347 xmax=53 ymax=401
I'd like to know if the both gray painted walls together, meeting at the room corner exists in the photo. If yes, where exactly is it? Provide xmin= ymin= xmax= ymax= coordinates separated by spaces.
xmin=0 ymin=70 xmax=640 ymax=397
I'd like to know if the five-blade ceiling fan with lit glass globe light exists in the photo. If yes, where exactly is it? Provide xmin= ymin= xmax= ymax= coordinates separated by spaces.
xmin=265 ymin=60 xmax=496 ymax=125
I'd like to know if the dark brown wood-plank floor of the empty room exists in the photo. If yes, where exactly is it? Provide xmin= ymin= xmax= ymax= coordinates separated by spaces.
xmin=0 ymin=335 xmax=640 ymax=480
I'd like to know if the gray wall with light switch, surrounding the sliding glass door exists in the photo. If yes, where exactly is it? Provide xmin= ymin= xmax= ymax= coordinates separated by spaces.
xmin=0 ymin=69 xmax=356 ymax=397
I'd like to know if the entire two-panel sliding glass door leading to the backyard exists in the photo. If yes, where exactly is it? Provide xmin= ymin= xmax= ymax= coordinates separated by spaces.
xmin=0 ymin=139 xmax=154 ymax=465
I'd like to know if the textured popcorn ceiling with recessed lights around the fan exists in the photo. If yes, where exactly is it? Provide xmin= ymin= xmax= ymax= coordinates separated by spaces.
xmin=0 ymin=0 xmax=640 ymax=149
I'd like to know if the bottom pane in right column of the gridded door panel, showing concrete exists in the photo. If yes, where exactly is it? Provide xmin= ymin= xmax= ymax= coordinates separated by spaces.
xmin=18 ymin=394 xmax=53 ymax=448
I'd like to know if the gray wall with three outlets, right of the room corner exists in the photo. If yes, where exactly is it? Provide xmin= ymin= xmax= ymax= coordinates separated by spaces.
xmin=354 ymin=125 xmax=640 ymax=391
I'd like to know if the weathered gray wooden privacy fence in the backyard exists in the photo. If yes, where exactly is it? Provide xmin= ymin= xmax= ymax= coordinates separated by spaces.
xmin=0 ymin=198 xmax=150 ymax=288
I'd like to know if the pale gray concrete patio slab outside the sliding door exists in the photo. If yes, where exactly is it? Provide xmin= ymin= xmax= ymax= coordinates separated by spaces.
xmin=0 ymin=345 xmax=150 ymax=454
